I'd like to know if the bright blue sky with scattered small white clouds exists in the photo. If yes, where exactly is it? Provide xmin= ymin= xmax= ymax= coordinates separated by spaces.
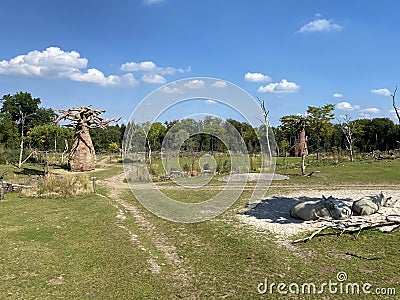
xmin=0 ymin=0 xmax=400 ymax=126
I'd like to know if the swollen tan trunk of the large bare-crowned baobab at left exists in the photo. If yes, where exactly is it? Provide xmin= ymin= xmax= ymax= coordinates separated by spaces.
xmin=68 ymin=127 xmax=96 ymax=172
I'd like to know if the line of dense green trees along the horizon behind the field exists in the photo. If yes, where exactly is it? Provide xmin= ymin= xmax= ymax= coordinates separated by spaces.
xmin=0 ymin=92 xmax=400 ymax=163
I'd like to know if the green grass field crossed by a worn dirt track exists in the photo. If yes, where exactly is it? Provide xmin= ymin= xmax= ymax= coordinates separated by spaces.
xmin=0 ymin=160 xmax=400 ymax=299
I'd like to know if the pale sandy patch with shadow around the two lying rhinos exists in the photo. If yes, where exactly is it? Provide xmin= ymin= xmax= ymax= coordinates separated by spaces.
xmin=238 ymin=189 xmax=400 ymax=240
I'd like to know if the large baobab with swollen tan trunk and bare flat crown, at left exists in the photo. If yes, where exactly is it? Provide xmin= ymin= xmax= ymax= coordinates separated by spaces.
xmin=54 ymin=106 xmax=120 ymax=172
